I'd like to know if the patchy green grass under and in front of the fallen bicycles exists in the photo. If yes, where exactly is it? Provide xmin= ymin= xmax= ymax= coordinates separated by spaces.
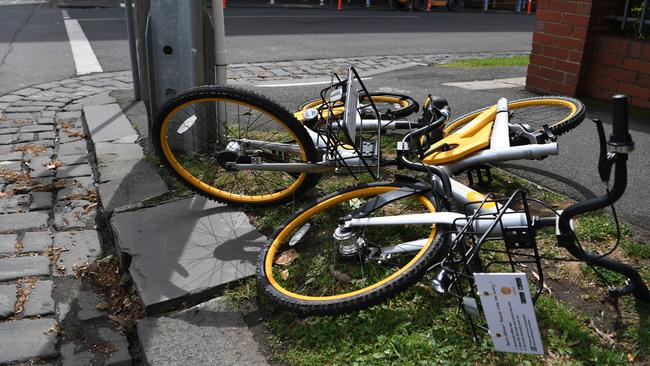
xmin=227 ymin=164 xmax=650 ymax=365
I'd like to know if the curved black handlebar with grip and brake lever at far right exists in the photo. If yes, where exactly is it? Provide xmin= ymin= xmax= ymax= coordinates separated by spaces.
xmin=557 ymin=95 xmax=650 ymax=302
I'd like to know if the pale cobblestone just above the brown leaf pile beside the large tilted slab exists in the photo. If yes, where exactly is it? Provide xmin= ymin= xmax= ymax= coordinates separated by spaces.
xmin=53 ymin=230 xmax=102 ymax=276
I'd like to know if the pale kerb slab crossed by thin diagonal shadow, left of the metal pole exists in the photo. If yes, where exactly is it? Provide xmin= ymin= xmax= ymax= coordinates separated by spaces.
xmin=83 ymin=103 xmax=138 ymax=143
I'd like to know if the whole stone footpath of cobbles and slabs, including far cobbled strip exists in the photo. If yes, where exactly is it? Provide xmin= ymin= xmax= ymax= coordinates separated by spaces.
xmin=0 ymin=53 xmax=636 ymax=365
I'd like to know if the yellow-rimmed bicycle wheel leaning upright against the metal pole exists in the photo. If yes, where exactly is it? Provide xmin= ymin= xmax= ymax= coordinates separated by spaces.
xmin=153 ymin=86 xmax=320 ymax=206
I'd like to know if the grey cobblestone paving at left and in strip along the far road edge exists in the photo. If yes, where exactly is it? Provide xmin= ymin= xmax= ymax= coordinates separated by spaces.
xmin=0 ymin=53 xmax=513 ymax=364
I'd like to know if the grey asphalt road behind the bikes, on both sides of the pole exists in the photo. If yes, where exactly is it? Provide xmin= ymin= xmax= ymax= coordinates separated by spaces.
xmin=0 ymin=2 xmax=533 ymax=95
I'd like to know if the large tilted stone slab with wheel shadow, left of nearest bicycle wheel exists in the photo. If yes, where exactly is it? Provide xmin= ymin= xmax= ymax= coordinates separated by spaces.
xmin=111 ymin=197 xmax=266 ymax=314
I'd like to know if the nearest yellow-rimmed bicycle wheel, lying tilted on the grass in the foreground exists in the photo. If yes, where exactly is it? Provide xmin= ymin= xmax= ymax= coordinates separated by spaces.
xmin=257 ymin=182 xmax=442 ymax=315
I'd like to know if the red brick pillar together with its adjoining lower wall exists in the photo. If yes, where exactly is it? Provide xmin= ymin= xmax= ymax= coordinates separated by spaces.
xmin=526 ymin=0 xmax=650 ymax=108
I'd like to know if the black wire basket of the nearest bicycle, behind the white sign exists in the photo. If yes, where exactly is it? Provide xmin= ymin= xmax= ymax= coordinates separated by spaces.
xmin=434 ymin=189 xmax=544 ymax=341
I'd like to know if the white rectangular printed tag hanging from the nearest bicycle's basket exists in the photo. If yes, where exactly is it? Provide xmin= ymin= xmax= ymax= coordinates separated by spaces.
xmin=474 ymin=273 xmax=544 ymax=355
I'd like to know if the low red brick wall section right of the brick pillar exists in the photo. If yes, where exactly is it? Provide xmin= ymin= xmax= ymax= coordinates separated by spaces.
xmin=584 ymin=35 xmax=650 ymax=109
